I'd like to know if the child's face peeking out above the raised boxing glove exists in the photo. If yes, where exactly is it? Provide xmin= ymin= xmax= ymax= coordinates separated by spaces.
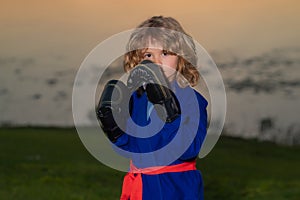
xmin=143 ymin=46 xmax=178 ymax=81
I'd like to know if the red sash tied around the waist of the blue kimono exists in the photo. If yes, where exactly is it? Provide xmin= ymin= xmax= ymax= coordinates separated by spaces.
xmin=120 ymin=160 xmax=196 ymax=200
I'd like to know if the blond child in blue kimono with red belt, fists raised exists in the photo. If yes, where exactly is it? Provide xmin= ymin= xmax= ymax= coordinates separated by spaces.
xmin=97 ymin=16 xmax=207 ymax=200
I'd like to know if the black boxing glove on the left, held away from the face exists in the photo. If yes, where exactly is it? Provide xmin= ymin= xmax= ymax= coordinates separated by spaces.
xmin=96 ymin=80 xmax=130 ymax=143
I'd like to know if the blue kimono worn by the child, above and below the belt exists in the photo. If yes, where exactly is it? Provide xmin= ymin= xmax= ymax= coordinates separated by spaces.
xmin=115 ymin=81 xmax=207 ymax=200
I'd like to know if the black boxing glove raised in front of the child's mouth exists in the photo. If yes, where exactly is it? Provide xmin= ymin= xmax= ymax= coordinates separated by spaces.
xmin=127 ymin=60 xmax=180 ymax=122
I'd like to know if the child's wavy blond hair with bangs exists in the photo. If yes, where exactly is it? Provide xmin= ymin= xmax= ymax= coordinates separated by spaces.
xmin=124 ymin=16 xmax=200 ymax=87
